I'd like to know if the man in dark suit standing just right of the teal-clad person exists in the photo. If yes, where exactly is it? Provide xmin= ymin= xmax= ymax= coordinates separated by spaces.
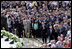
xmin=41 ymin=22 xmax=48 ymax=43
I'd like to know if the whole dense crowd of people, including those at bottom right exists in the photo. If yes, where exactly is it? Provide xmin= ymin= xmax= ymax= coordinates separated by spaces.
xmin=1 ymin=1 xmax=71 ymax=48
